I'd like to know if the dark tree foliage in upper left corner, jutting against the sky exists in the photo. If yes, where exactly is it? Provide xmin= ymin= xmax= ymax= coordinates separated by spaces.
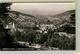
xmin=0 ymin=3 xmax=12 ymax=24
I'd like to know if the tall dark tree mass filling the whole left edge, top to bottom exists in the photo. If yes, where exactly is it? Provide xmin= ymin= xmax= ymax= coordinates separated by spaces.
xmin=0 ymin=3 xmax=13 ymax=48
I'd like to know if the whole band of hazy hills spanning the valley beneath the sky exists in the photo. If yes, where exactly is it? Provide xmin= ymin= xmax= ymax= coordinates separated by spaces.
xmin=2 ymin=10 xmax=75 ymax=28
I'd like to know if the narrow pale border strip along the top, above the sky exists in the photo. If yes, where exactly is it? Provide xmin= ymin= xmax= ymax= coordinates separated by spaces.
xmin=0 ymin=0 xmax=76 ymax=3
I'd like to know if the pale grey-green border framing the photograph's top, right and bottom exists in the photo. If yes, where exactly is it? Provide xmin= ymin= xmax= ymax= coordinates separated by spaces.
xmin=0 ymin=0 xmax=80 ymax=54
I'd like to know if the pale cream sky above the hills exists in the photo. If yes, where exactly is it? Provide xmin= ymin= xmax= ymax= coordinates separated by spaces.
xmin=11 ymin=3 xmax=75 ymax=15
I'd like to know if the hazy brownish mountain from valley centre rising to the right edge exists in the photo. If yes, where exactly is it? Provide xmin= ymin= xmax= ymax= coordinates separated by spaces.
xmin=30 ymin=10 xmax=75 ymax=25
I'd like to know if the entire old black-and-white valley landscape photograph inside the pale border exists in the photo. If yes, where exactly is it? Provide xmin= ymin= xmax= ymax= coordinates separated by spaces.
xmin=0 ymin=3 xmax=76 ymax=51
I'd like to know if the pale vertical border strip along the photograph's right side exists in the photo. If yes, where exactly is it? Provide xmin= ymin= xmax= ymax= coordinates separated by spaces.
xmin=76 ymin=0 xmax=80 ymax=51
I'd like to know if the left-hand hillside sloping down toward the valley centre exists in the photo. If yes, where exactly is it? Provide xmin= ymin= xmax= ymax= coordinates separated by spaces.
xmin=9 ymin=11 xmax=37 ymax=27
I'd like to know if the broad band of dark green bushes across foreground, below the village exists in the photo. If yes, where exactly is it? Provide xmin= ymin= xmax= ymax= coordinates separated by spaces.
xmin=13 ymin=28 xmax=75 ymax=50
